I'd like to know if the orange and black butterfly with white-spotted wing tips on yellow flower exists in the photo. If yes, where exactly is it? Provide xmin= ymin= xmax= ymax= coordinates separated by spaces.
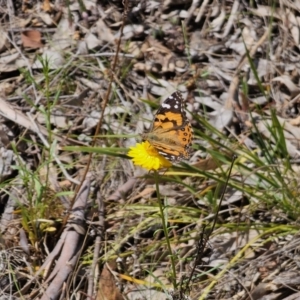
xmin=142 ymin=91 xmax=193 ymax=162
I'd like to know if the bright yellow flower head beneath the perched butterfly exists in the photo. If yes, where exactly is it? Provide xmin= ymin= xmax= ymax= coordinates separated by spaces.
xmin=128 ymin=141 xmax=172 ymax=171
